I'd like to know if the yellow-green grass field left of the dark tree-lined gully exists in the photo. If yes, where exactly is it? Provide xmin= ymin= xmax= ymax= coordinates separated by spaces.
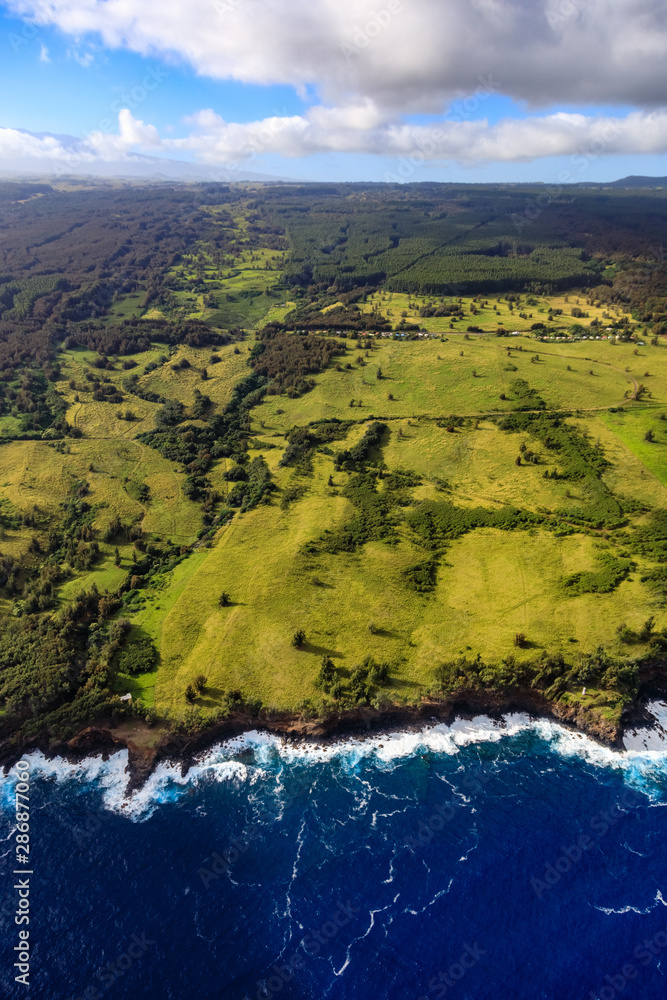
xmin=0 ymin=336 xmax=211 ymax=602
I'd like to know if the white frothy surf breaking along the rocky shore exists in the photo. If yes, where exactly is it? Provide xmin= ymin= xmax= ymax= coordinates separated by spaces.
xmin=0 ymin=702 xmax=667 ymax=821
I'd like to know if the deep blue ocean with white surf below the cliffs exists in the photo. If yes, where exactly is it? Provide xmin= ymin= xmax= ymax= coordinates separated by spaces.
xmin=0 ymin=716 xmax=667 ymax=1000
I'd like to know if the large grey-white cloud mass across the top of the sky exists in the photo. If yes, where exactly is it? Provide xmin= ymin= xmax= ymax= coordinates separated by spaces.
xmin=6 ymin=0 xmax=667 ymax=113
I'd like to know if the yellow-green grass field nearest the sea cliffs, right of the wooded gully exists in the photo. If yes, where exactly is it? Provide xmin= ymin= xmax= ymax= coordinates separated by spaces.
xmin=124 ymin=452 xmax=667 ymax=713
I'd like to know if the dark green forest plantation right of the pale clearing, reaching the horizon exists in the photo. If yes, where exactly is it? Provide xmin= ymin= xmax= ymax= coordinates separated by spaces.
xmin=263 ymin=184 xmax=667 ymax=295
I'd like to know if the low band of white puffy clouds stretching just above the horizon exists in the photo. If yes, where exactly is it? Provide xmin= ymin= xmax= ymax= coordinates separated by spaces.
xmin=0 ymin=102 xmax=667 ymax=168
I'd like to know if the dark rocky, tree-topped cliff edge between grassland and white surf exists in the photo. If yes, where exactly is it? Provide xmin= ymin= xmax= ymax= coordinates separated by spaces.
xmin=0 ymin=685 xmax=665 ymax=795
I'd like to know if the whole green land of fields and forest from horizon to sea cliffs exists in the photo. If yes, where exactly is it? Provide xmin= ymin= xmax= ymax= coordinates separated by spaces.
xmin=0 ymin=183 xmax=667 ymax=743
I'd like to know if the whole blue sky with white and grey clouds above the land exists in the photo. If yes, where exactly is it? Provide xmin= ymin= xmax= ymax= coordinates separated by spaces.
xmin=0 ymin=0 xmax=667 ymax=185
